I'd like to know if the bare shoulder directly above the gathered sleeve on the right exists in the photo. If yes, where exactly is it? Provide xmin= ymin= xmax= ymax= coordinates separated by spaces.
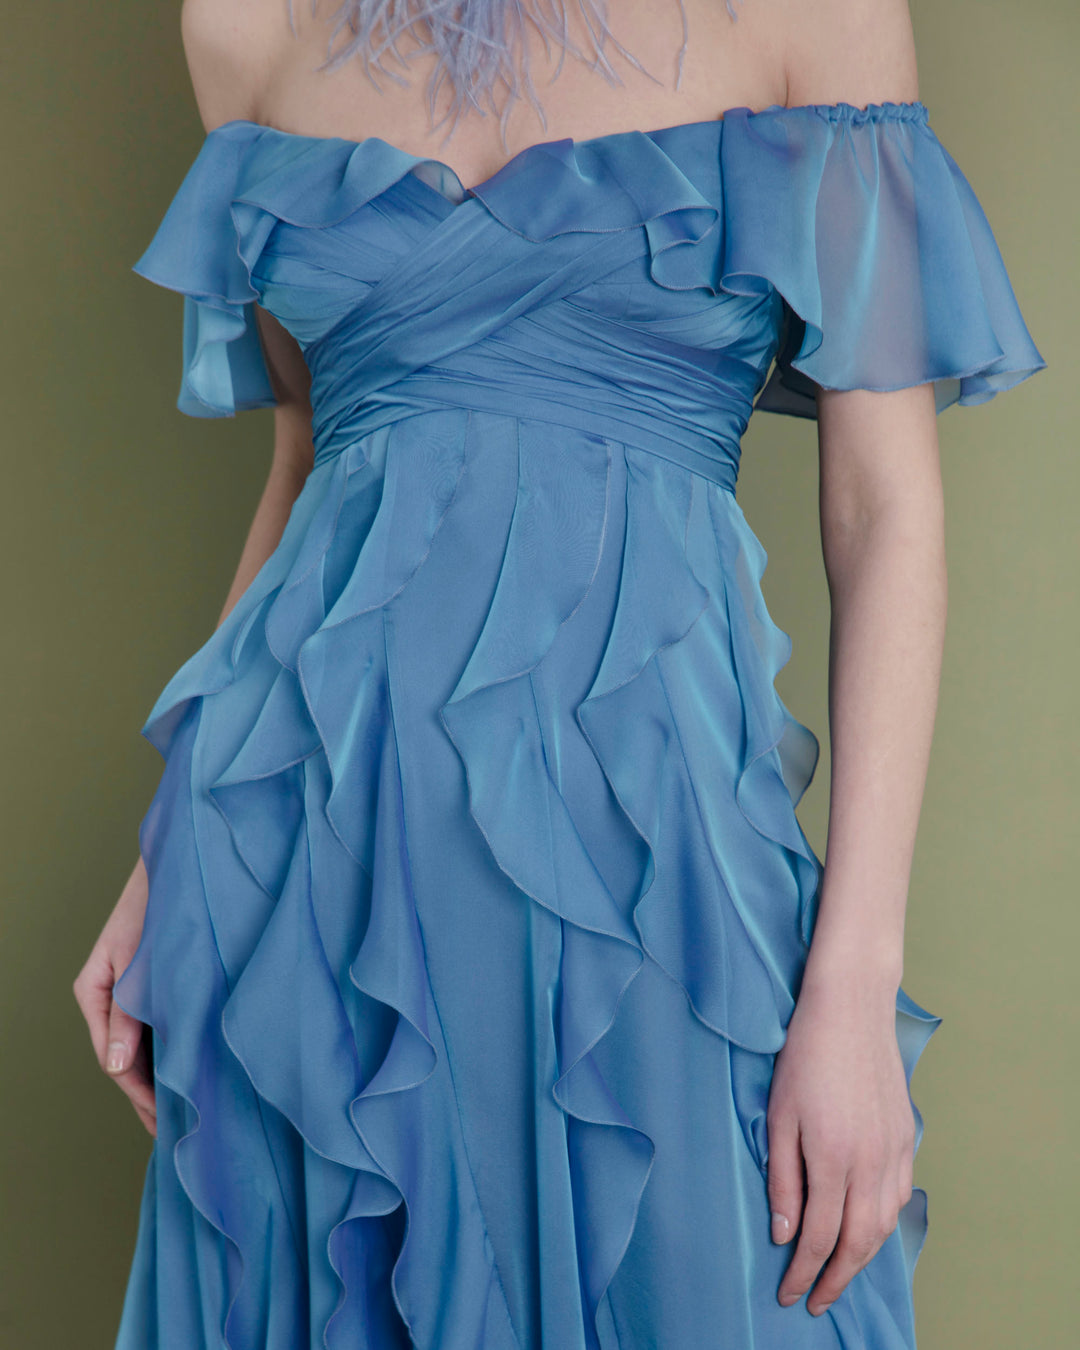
xmin=772 ymin=0 xmax=918 ymax=108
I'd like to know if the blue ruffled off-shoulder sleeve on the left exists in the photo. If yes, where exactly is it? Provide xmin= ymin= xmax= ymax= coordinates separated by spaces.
xmin=132 ymin=128 xmax=277 ymax=417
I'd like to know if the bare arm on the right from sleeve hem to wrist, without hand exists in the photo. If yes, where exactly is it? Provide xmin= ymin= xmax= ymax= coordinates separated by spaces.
xmin=805 ymin=385 xmax=946 ymax=988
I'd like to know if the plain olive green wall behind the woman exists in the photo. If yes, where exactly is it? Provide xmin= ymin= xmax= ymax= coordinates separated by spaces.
xmin=0 ymin=0 xmax=1080 ymax=1350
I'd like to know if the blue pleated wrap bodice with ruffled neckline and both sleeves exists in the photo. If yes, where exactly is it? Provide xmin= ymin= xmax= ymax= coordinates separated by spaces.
xmin=135 ymin=103 xmax=1045 ymax=486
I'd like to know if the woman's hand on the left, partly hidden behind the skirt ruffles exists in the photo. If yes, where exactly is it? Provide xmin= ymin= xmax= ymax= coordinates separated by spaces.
xmin=73 ymin=857 xmax=158 ymax=1138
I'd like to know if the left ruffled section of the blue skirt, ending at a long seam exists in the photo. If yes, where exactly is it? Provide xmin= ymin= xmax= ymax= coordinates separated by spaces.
xmin=115 ymin=410 xmax=517 ymax=1350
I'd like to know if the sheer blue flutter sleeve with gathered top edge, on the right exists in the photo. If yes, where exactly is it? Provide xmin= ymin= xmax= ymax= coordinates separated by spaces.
xmin=722 ymin=103 xmax=1046 ymax=417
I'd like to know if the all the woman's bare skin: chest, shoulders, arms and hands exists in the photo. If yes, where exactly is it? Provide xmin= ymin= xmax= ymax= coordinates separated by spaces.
xmin=74 ymin=0 xmax=946 ymax=1315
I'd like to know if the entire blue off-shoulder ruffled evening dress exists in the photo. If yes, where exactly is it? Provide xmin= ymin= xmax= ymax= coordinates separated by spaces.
xmin=115 ymin=103 xmax=1045 ymax=1350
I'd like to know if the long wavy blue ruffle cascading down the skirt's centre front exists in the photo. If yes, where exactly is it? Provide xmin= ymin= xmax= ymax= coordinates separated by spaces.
xmin=440 ymin=423 xmax=653 ymax=1345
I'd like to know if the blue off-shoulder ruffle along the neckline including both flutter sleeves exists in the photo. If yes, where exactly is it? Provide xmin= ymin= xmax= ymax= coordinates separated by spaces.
xmin=134 ymin=103 xmax=1046 ymax=417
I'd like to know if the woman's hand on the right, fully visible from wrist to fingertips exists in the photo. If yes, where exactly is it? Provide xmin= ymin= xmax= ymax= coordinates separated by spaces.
xmin=765 ymin=965 xmax=915 ymax=1315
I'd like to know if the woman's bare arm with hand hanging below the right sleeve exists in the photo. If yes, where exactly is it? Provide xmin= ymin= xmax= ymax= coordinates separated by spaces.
xmin=767 ymin=385 xmax=946 ymax=1312
